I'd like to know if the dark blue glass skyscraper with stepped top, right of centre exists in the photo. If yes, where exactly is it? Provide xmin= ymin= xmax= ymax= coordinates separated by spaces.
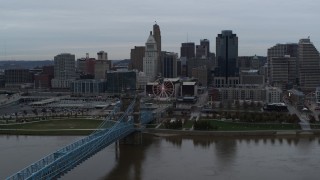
xmin=214 ymin=30 xmax=239 ymax=86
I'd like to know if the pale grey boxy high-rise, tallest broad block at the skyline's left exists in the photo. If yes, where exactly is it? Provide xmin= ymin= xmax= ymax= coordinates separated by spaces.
xmin=51 ymin=53 xmax=76 ymax=88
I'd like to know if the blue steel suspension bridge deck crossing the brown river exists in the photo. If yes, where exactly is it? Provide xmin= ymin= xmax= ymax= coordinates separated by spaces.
xmin=7 ymin=98 xmax=153 ymax=180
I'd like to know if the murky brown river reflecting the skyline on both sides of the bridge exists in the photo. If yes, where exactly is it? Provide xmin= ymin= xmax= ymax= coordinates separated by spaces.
xmin=0 ymin=135 xmax=320 ymax=180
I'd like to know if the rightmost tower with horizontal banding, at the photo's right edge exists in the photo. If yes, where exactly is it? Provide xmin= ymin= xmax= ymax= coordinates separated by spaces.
xmin=298 ymin=39 xmax=320 ymax=93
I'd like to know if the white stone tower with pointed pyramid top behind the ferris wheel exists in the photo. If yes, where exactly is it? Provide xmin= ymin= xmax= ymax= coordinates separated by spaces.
xmin=143 ymin=32 xmax=159 ymax=82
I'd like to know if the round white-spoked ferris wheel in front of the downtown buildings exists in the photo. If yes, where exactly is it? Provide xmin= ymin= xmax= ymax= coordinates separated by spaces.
xmin=152 ymin=78 xmax=174 ymax=100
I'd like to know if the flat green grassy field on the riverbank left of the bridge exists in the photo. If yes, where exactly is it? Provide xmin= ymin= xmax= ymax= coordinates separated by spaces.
xmin=0 ymin=119 xmax=103 ymax=135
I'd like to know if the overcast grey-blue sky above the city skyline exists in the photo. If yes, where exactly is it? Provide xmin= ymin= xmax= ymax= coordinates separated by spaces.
xmin=0 ymin=0 xmax=320 ymax=60
